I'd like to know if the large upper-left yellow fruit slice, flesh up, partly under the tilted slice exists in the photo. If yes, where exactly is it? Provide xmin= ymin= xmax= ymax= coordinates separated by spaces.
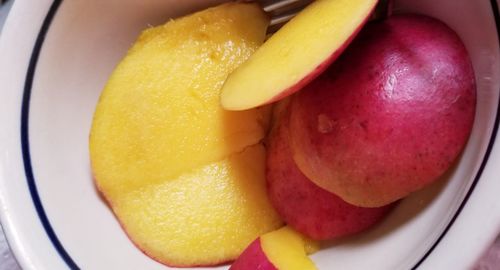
xmin=90 ymin=3 xmax=269 ymax=196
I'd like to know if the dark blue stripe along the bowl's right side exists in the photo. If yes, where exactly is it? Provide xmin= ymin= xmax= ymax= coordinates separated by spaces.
xmin=412 ymin=0 xmax=500 ymax=269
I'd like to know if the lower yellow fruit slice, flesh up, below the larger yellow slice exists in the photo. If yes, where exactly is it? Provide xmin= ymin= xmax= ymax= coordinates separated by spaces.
xmin=114 ymin=144 xmax=282 ymax=266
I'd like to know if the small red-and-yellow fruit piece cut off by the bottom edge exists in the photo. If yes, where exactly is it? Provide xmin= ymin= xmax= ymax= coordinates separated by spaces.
xmin=230 ymin=227 xmax=319 ymax=270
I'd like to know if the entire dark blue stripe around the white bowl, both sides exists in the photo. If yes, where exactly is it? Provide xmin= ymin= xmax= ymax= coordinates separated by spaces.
xmin=21 ymin=0 xmax=500 ymax=270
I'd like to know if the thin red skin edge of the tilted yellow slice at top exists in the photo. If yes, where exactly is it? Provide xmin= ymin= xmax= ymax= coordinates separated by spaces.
xmin=263 ymin=8 xmax=376 ymax=105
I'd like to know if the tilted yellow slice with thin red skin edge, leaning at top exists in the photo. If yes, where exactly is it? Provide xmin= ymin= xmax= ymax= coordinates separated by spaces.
xmin=221 ymin=0 xmax=377 ymax=110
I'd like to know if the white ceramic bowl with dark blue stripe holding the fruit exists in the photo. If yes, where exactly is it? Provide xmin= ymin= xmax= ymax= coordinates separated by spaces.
xmin=0 ymin=0 xmax=500 ymax=270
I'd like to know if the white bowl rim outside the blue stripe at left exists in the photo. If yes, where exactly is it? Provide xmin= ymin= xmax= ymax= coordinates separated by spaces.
xmin=0 ymin=0 xmax=71 ymax=270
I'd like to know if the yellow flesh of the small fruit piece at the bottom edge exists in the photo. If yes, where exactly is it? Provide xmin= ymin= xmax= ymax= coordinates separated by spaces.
xmin=261 ymin=226 xmax=319 ymax=270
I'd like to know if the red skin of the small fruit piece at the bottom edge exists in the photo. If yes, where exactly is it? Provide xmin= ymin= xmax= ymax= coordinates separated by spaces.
xmin=229 ymin=237 xmax=278 ymax=270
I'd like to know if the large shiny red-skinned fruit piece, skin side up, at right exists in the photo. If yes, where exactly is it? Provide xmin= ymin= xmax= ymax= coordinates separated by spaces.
xmin=290 ymin=15 xmax=476 ymax=207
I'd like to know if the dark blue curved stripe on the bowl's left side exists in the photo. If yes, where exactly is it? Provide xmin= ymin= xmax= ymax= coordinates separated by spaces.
xmin=21 ymin=0 xmax=80 ymax=270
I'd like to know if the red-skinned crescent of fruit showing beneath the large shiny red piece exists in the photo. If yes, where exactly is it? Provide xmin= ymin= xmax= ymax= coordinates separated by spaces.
xmin=266 ymin=106 xmax=393 ymax=240
